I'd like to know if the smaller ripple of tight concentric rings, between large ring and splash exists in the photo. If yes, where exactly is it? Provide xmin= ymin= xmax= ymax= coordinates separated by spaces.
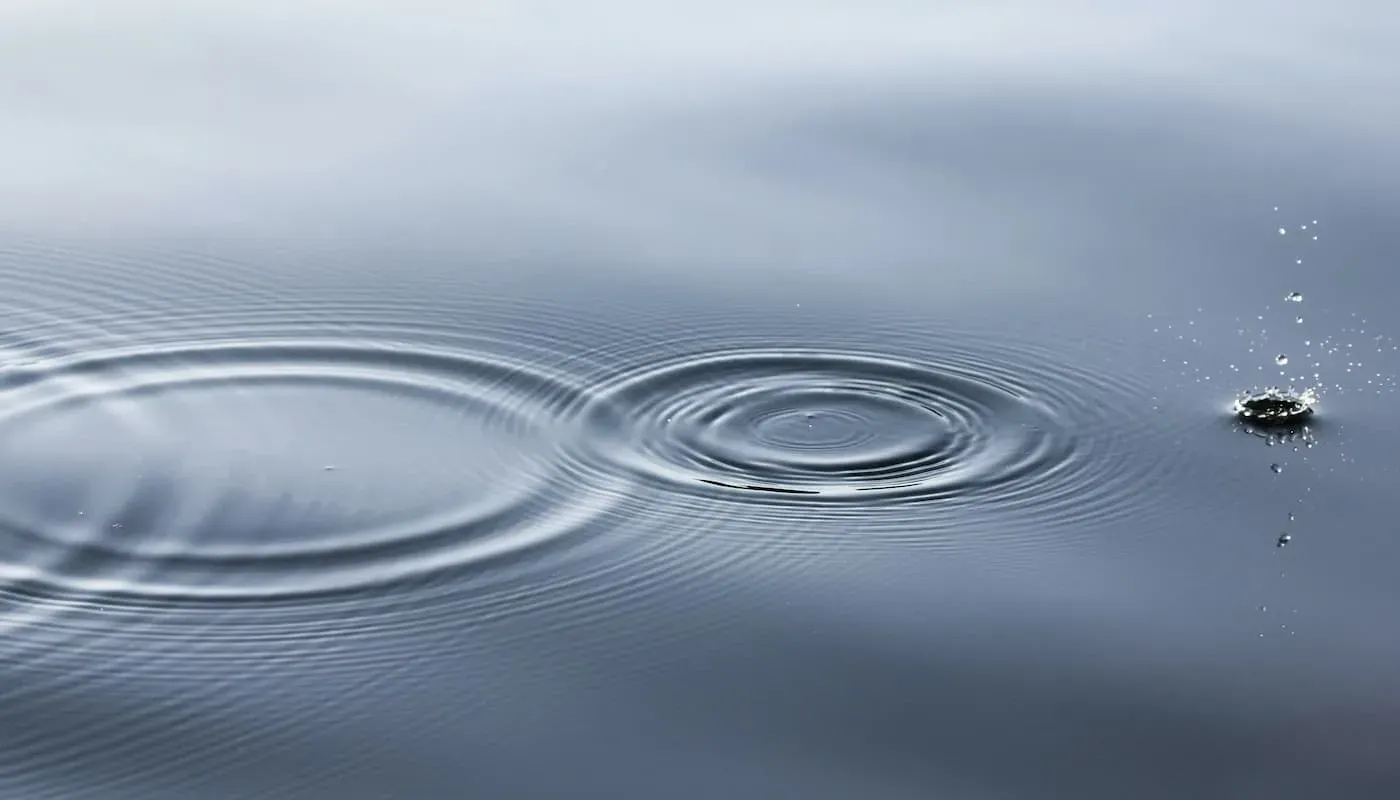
xmin=574 ymin=345 xmax=1163 ymax=534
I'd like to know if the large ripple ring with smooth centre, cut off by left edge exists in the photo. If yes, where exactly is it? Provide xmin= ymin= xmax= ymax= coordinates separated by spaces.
xmin=0 ymin=343 xmax=616 ymax=600
